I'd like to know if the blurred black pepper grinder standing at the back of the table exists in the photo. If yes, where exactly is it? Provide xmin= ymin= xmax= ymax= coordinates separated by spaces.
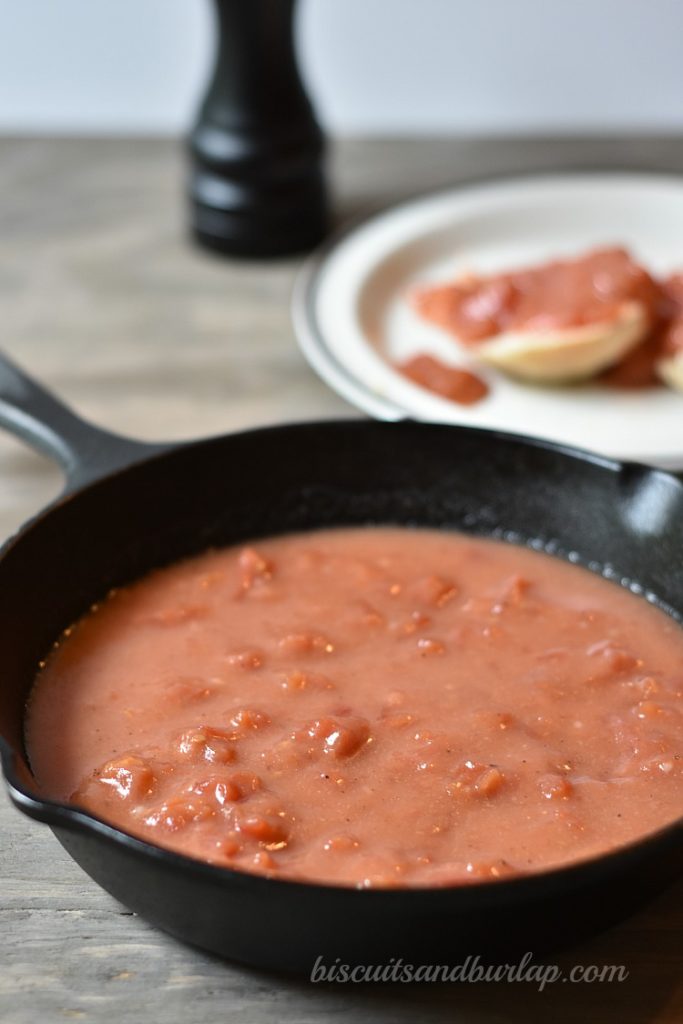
xmin=189 ymin=0 xmax=328 ymax=258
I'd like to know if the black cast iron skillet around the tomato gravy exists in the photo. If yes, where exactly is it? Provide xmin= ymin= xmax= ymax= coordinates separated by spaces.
xmin=0 ymin=360 xmax=683 ymax=972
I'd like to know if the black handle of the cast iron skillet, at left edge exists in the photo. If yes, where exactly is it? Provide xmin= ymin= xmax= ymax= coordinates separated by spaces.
xmin=0 ymin=353 xmax=170 ymax=494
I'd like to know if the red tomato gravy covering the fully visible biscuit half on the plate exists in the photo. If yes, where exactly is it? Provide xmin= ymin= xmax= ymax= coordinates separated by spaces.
xmin=414 ymin=248 xmax=659 ymax=344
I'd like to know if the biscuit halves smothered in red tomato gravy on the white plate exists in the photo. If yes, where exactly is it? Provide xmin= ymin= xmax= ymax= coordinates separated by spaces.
xmin=413 ymin=248 xmax=683 ymax=387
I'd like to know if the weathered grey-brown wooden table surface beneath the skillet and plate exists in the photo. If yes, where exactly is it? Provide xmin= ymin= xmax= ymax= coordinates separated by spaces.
xmin=0 ymin=138 xmax=683 ymax=1024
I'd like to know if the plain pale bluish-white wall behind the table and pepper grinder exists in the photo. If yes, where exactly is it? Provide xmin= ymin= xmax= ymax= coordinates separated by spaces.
xmin=0 ymin=0 xmax=683 ymax=133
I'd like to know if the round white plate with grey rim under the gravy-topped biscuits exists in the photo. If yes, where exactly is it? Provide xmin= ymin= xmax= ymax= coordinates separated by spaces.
xmin=293 ymin=173 xmax=683 ymax=465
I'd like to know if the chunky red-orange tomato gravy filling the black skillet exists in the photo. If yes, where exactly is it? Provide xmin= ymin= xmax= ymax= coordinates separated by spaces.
xmin=27 ymin=527 xmax=683 ymax=887
